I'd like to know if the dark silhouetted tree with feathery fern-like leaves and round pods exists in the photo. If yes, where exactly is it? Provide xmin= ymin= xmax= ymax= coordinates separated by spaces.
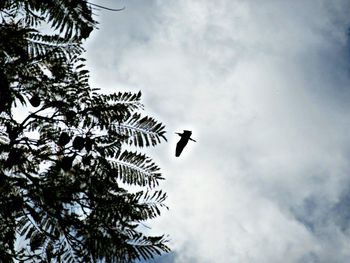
xmin=0 ymin=0 xmax=169 ymax=262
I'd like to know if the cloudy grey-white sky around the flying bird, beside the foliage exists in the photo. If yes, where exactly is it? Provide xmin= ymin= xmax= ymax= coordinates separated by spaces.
xmin=86 ymin=0 xmax=350 ymax=263
